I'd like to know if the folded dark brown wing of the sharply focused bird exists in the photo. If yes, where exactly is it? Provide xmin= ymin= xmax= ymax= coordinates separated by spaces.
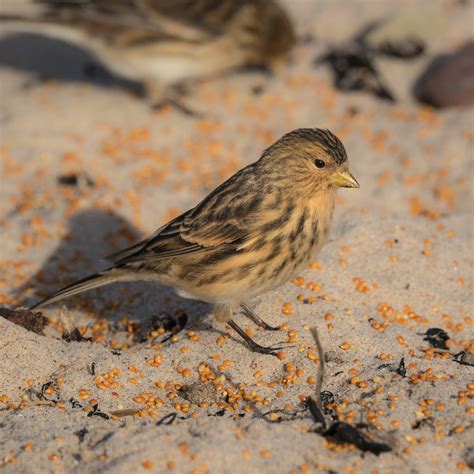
xmin=109 ymin=165 xmax=265 ymax=264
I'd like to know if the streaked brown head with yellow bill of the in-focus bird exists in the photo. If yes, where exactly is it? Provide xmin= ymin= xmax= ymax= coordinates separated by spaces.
xmin=259 ymin=128 xmax=359 ymax=198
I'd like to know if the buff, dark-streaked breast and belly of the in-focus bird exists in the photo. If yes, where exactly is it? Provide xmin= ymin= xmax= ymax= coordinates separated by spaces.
xmin=154 ymin=193 xmax=333 ymax=303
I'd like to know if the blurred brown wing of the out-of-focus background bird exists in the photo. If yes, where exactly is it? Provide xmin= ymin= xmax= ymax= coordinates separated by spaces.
xmin=31 ymin=0 xmax=249 ymax=45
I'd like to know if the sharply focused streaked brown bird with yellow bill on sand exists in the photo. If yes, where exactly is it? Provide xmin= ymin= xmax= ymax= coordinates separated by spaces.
xmin=31 ymin=128 xmax=359 ymax=354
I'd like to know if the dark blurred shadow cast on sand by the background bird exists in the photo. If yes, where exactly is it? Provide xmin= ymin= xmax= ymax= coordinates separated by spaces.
xmin=0 ymin=33 xmax=144 ymax=96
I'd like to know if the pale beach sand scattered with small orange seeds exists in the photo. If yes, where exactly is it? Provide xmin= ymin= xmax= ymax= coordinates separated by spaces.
xmin=0 ymin=0 xmax=474 ymax=473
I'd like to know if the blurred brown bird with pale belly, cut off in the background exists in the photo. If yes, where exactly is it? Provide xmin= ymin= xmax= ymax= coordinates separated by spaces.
xmin=0 ymin=0 xmax=295 ymax=104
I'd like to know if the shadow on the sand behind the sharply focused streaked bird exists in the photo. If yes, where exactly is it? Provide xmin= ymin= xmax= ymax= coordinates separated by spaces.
xmin=15 ymin=209 xmax=211 ymax=325
